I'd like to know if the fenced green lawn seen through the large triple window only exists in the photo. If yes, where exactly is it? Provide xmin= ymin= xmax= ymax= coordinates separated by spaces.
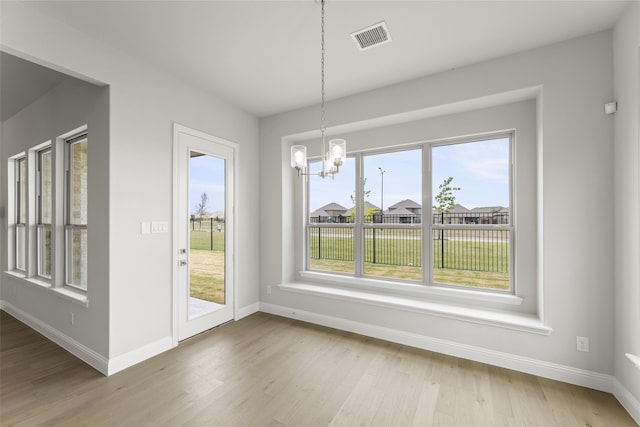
xmin=309 ymin=228 xmax=510 ymax=290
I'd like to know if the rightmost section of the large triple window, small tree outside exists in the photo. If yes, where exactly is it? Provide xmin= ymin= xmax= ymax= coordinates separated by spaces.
xmin=431 ymin=136 xmax=513 ymax=291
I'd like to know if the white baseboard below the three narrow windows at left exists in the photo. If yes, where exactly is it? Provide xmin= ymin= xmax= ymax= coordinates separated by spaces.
xmin=0 ymin=301 xmax=109 ymax=375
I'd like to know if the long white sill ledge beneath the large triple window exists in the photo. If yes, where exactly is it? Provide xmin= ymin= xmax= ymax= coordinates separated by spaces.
xmin=278 ymin=283 xmax=552 ymax=335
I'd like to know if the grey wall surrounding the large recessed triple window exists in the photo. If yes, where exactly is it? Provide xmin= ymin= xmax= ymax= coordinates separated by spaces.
xmin=260 ymin=31 xmax=614 ymax=378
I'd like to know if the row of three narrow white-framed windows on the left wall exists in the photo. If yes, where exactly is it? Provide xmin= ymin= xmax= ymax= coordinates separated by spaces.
xmin=7 ymin=126 xmax=88 ymax=300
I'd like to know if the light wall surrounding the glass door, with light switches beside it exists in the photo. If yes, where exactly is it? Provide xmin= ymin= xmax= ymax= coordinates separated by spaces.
xmin=1 ymin=2 xmax=259 ymax=372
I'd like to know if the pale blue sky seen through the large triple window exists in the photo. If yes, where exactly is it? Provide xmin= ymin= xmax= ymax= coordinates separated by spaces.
xmin=310 ymin=138 xmax=509 ymax=211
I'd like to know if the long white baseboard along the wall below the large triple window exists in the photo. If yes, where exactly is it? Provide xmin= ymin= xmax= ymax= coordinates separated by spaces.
xmin=260 ymin=302 xmax=614 ymax=393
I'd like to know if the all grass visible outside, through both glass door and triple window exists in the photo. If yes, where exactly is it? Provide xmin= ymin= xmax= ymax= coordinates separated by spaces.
xmin=191 ymin=229 xmax=509 ymax=296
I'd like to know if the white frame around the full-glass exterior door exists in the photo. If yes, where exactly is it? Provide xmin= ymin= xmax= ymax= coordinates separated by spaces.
xmin=171 ymin=123 xmax=239 ymax=347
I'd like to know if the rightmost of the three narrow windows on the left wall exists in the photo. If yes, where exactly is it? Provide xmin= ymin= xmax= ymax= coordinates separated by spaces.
xmin=65 ymin=133 xmax=88 ymax=290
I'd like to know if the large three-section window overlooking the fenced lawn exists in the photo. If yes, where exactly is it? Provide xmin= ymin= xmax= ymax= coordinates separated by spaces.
xmin=305 ymin=133 xmax=514 ymax=292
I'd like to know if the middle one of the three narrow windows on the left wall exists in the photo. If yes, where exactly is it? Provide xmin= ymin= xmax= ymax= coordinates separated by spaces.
xmin=36 ymin=146 xmax=53 ymax=280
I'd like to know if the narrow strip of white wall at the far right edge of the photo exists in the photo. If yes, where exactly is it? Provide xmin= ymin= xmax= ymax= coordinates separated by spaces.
xmin=612 ymin=2 xmax=640 ymax=422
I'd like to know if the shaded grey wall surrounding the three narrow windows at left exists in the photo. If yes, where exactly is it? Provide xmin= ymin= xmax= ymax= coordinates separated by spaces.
xmin=0 ymin=77 xmax=109 ymax=362
